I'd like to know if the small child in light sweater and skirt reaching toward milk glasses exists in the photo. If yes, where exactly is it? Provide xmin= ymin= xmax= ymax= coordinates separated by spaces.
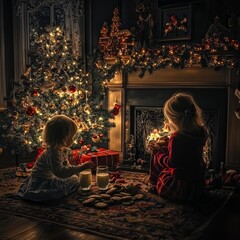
xmin=18 ymin=115 xmax=94 ymax=202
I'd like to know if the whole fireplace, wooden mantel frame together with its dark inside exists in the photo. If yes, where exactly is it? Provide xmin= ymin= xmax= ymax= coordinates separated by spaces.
xmin=108 ymin=67 xmax=240 ymax=169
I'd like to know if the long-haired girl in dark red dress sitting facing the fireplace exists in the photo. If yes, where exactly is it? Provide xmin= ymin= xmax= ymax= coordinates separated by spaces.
xmin=148 ymin=92 xmax=207 ymax=203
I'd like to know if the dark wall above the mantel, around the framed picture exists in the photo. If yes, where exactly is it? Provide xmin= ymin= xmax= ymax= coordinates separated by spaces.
xmin=87 ymin=0 xmax=240 ymax=52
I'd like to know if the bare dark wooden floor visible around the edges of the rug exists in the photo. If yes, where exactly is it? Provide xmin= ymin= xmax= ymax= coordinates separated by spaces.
xmin=0 ymin=151 xmax=240 ymax=240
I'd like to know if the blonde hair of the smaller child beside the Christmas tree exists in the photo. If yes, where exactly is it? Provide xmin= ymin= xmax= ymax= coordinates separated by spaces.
xmin=43 ymin=115 xmax=77 ymax=148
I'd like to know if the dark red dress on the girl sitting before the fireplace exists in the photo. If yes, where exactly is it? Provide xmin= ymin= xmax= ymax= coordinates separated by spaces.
xmin=150 ymin=129 xmax=206 ymax=202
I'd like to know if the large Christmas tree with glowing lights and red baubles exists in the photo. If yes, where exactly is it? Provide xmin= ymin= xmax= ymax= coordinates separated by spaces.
xmin=0 ymin=27 xmax=114 ymax=154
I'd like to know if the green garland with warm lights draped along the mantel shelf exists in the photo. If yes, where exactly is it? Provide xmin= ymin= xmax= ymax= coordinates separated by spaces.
xmin=90 ymin=37 xmax=240 ymax=82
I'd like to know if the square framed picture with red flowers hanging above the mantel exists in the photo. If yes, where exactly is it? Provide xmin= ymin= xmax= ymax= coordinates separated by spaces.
xmin=159 ymin=4 xmax=192 ymax=42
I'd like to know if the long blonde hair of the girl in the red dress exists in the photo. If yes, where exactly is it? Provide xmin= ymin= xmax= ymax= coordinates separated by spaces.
xmin=163 ymin=92 xmax=204 ymax=131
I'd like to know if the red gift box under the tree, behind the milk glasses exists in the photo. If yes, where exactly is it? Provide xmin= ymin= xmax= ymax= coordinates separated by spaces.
xmin=73 ymin=148 xmax=119 ymax=167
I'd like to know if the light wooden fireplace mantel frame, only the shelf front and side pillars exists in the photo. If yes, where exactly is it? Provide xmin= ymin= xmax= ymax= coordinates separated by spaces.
xmin=108 ymin=67 xmax=240 ymax=169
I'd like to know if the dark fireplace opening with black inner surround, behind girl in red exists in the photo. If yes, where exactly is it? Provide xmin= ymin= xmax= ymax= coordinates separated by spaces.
xmin=125 ymin=89 xmax=227 ymax=172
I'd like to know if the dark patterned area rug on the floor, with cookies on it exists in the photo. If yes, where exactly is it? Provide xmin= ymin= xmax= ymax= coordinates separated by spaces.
xmin=0 ymin=169 xmax=233 ymax=240
